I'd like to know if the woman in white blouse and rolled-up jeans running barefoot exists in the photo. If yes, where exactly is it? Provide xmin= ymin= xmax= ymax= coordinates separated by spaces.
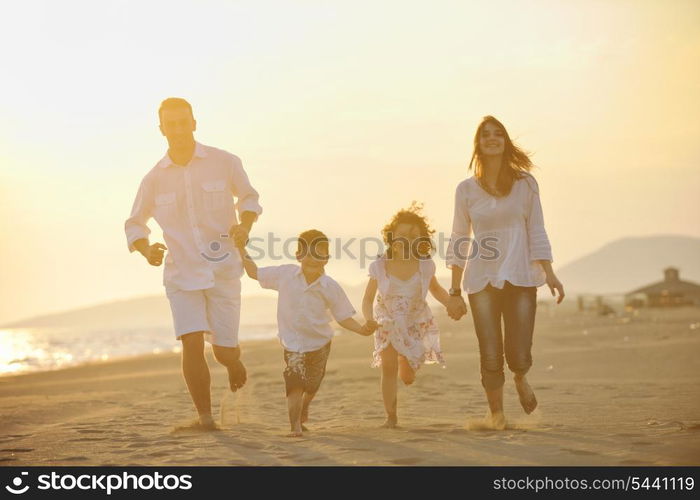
xmin=447 ymin=116 xmax=564 ymax=429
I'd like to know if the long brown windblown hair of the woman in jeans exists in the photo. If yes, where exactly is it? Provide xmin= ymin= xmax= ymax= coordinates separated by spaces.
xmin=469 ymin=115 xmax=534 ymax=196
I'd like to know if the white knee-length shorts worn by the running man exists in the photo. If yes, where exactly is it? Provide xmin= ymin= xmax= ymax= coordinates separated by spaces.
xmin=165 ymin=277 xmax=241 ymax=347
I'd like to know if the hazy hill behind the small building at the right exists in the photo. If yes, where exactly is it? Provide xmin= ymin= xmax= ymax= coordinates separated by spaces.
xmin=556 ymin=235 xmax=700 ymax=294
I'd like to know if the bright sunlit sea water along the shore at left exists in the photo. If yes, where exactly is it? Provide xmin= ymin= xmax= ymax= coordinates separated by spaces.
xmin=0 ymin=324 xmax=277 ymax=376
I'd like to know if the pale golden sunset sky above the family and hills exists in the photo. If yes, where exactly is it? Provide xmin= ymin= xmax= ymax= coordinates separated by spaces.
xmin=0 ymin=0 xmax=700 ymax=324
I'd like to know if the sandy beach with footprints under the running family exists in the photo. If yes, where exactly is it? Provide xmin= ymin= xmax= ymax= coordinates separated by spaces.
xmin=0 ymin=302 xmax=700 ymax=465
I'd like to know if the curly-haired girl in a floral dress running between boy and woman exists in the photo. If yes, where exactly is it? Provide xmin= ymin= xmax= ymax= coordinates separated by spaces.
xmin=362 ymin=202 xmax=449 ymax=428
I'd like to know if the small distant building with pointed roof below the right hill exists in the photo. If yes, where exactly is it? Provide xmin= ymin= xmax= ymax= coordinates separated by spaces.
xmin=625 ymin=267 xmax=700 ymax=307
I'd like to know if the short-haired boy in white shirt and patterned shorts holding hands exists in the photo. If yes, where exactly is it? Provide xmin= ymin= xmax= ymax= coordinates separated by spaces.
xmin=236 ymin=229 xmax=377 ymax=437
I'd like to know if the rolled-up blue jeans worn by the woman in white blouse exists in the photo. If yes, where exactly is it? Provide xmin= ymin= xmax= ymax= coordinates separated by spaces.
xmin=468 ymin=281 xmax=537 ymax=391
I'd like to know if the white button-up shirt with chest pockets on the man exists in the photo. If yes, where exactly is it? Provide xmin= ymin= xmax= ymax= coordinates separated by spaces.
xmin=124 ymin=142 xmax=262 ymax=290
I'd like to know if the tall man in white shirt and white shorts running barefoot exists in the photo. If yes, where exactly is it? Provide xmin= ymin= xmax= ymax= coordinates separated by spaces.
xmin=125 ymin=98 xmax=262 ymax=429
